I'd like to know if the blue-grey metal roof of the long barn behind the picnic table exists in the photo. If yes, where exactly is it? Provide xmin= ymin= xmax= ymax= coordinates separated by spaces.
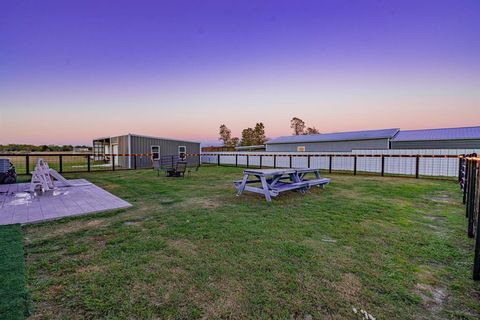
xmin=267 ymin=129 xmax=399 ymax=144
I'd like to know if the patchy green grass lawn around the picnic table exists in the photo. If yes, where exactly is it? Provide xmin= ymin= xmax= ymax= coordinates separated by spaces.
xmin=11 ymin=167 xmax=480 ymax=319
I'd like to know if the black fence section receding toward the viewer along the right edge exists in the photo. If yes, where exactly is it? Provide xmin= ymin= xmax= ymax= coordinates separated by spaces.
xmin=459 ymin=154 xmax=480 ymax=280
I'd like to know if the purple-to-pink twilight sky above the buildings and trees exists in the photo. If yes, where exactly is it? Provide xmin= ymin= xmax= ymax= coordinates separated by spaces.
xmin=0 ymin=0 xmax=480 ymax=144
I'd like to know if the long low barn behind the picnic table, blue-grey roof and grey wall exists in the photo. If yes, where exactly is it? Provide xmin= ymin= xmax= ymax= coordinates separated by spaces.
xmin=266 ymin=129 xmax=399 ymax=152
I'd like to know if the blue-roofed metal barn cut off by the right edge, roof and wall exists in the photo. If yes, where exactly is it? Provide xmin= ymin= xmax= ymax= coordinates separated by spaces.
xmin=391 ymin=127 xmax=480 ymax=149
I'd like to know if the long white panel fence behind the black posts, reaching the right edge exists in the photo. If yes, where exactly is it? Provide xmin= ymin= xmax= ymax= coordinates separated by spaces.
xmin=201 ymin=149 xmax=480 ymax=177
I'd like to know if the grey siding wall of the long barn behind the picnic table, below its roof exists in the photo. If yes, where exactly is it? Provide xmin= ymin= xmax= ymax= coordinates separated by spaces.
xmin=266 ymin=139 xmax=389 ymax=152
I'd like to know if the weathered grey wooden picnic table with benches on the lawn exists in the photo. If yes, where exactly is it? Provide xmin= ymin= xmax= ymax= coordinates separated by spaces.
xmin=234 ymin=168 xmax=330 ymax=201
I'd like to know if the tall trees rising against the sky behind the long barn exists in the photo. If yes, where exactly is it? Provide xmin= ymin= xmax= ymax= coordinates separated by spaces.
xmin=218 ymin=117 xmax=320 ymax=148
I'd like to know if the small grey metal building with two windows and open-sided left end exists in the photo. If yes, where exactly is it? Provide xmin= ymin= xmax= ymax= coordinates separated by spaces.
xmin=93 ymin=133 xmax=200 ymax=169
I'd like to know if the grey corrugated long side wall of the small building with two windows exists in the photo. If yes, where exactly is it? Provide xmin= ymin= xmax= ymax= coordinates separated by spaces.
xmin=127 ymin=135 xmax=200 ymax=168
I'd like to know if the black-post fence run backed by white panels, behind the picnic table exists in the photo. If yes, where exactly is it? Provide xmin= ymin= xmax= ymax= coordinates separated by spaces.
xmin=201 ymin=152 xmax=460 ymax=178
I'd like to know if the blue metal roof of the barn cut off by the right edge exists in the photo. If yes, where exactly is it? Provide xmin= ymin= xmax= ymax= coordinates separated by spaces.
xmin=392 ymin=126 xmax=480 ymax=141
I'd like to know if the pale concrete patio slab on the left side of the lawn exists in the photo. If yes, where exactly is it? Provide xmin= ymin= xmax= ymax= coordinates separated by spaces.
xmin=0 ymin=179 xmax=131 ymax=225
